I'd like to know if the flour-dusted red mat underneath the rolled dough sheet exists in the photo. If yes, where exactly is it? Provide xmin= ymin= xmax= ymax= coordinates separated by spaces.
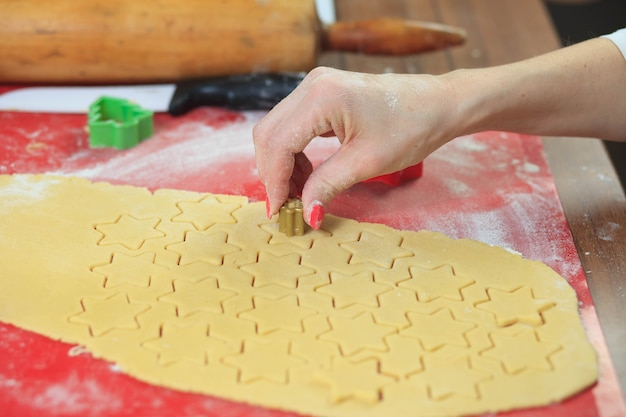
xmin=0 ymin=101 xmax=624 ymax=417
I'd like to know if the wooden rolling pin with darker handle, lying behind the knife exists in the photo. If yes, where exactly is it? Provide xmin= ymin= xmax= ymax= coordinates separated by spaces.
xmin=0 ymin=0 xmax=465 ymax=83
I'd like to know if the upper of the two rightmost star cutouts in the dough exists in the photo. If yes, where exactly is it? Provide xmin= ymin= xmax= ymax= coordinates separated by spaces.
xmin=476 ymin=287 xmax=554 ymax=327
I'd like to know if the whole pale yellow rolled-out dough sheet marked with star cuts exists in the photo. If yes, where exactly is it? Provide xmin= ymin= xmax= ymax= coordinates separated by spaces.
xmin=0 ymin=175 xmax=598 ymax=417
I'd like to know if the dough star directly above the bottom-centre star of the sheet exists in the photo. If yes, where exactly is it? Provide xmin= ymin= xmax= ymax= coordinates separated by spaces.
xmin=319 ymin=313 xmax=396 ymax=356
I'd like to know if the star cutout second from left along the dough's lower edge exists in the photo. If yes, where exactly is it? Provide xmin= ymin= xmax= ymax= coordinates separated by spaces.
xmin=142 ymin=323 xmax=229 ymax=366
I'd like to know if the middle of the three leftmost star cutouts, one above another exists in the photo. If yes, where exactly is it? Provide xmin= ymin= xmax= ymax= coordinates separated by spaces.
xmin=92 ymin=252 xmax=167 ymax=288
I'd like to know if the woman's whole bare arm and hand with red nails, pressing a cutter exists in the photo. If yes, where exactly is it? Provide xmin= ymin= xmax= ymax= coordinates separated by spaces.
xmin=253 ymin=35 xmax=626 ymax=224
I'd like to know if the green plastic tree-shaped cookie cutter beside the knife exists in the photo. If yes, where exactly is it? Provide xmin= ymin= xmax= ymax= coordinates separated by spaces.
xmin=87 ymin=96 xmax=154 ymax=149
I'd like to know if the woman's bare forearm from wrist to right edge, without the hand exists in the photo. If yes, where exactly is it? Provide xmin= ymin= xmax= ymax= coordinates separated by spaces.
xmin=443 ymin=39 xmax=626 ymax=141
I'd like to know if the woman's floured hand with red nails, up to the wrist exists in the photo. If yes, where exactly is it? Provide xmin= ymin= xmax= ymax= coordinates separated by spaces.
xmin=253 ymin=68 xmax=457 ymax=229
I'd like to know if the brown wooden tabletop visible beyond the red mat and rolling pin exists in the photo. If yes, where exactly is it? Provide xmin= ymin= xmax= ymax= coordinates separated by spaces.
xmin=320 ymin=0 xmax=626 ymax=404
